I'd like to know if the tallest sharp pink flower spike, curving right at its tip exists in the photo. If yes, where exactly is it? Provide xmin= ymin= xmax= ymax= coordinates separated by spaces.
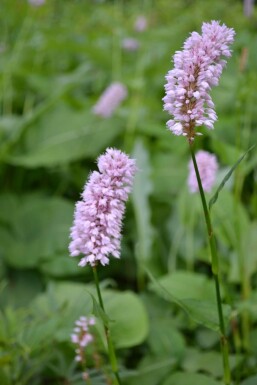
xmin=163 ymin=21 xmax=235 ymax=141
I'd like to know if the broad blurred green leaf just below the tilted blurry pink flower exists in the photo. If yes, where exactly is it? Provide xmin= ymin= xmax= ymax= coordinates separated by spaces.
xmin=8 ymin=103 xmax=121 ymax=168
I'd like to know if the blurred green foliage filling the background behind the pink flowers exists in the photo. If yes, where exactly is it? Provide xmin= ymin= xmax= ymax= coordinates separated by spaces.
xmin=0 ymin=0 xmax=257 ymax=385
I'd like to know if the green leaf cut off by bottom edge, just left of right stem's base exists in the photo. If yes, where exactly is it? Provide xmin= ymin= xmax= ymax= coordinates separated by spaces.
xmin=161 ymin=372 xmax=222 ymax=385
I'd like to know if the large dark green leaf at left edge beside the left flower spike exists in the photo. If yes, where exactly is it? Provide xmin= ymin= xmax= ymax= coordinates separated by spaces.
xmin=0 ymin=194 xmax=74 ymax=269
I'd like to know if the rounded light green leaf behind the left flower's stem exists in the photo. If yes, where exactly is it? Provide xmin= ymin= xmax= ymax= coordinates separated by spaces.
xmin=34 ymin=282 xmax=149 ymax=348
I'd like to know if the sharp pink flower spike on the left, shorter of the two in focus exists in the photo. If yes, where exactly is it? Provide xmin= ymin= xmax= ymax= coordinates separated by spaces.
xmin=69 ymin=148 xmax=136 ymax=266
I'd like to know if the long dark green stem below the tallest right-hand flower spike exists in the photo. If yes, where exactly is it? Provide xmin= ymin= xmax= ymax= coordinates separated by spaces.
xmin=189 ymin=141 xmax=231 ymax=385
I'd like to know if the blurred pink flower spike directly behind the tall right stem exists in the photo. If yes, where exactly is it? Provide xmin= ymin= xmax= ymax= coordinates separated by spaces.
xmin=188 ymin=150 xmax=218 ymax=193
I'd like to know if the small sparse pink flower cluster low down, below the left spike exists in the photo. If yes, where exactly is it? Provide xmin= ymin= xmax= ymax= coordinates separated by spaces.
xmin=71 ymin=316 xmax=95 ymax=363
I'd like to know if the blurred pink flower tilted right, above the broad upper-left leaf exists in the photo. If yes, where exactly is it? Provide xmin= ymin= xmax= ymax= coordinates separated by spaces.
xmin=93 ymin=82 xmax=128 ymax=118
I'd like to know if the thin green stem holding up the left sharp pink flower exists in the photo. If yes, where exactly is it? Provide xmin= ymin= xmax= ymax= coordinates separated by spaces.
xmin=93 ymin=266 xmax=121 ymax=385
